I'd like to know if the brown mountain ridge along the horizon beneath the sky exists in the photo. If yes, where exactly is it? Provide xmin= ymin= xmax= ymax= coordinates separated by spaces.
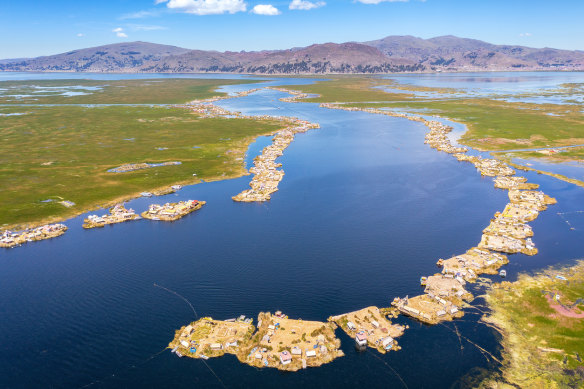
xmin=0 ymin=35 xmax=584 ymax=74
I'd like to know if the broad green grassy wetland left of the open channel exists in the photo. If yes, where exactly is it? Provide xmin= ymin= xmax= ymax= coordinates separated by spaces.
xmin=0 ymin=79 xmax=281 ymax=228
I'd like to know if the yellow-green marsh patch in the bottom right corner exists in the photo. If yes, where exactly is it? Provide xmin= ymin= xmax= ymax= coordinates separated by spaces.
xmin=481 ymin=261 xmax=584 ymax=388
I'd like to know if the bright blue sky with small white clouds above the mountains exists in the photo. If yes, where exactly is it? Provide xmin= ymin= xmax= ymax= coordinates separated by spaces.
xmin=0 ymin=0 xmax=584 ymax=58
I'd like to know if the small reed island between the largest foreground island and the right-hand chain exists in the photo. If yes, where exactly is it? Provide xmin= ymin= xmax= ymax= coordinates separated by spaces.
xmin=328 ymin=307 xmax=405 ymax=354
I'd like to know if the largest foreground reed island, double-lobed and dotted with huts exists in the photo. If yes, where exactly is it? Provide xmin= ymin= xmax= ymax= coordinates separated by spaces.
xmin=169 ymin=312 xmax=344 ymax=371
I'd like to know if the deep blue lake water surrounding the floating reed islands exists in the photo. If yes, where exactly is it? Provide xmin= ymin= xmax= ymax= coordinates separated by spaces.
xmin=0 ymin=73 xmax=584 ymax=388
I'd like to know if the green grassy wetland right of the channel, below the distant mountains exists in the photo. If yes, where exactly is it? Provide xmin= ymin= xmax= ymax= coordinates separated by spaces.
xmin=289 ymin=77 xmax=584 ymax=183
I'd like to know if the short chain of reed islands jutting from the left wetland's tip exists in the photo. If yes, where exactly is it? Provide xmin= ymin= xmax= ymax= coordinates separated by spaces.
xmin=232 ymin=118 xmax=320 ymax=202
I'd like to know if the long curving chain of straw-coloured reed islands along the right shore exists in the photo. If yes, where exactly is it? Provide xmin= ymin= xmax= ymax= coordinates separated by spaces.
xmin=314 ymin=104 xmax=556 ymax=324
